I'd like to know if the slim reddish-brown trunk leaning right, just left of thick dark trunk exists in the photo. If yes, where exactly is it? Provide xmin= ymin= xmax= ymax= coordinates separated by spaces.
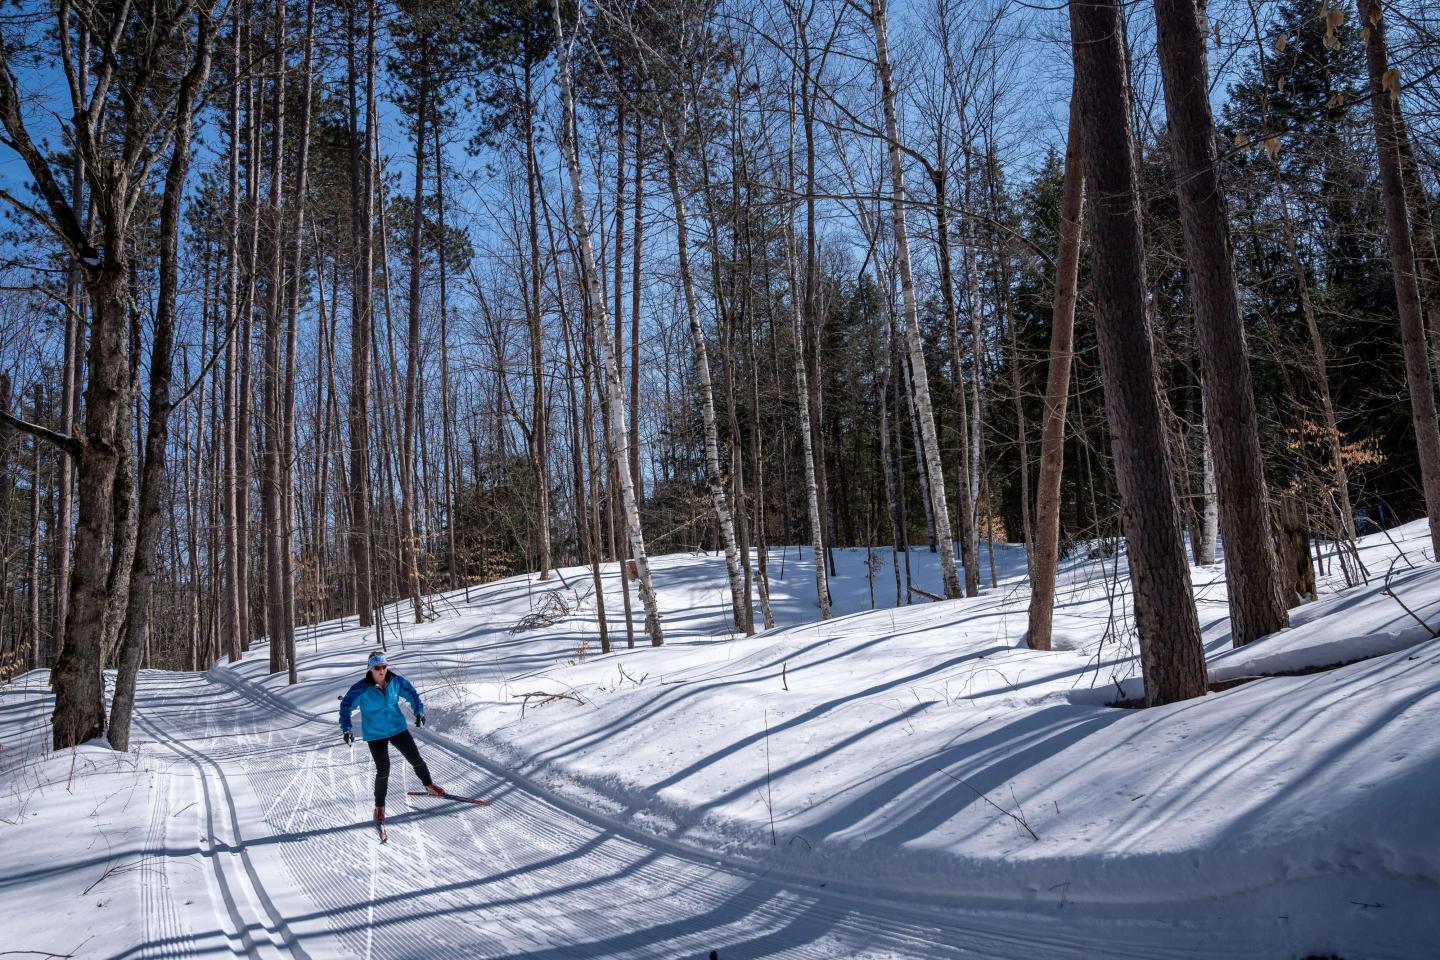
xmin=1025 ymin=89 xmax=1084 ymax=651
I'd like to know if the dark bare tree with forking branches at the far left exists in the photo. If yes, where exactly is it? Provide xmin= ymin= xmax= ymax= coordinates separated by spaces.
xmin=0 ymin=4 xmax=212 ymax=748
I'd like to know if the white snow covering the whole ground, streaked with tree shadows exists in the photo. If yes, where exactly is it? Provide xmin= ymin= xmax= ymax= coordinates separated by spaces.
xmin=0 ymin=522 xmax=1440 ymax=960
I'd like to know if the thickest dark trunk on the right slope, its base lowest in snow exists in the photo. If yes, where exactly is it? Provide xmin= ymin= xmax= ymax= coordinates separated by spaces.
xmin=1070 ymin=0 xmax=1205 ymax=705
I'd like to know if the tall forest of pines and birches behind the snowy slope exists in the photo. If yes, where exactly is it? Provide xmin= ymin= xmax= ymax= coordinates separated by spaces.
xmin=0 ymin=0 xmax=1440 ymax=750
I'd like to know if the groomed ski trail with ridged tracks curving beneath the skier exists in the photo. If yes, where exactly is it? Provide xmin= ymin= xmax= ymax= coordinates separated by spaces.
xmin=120 ymin=669 xmax=1272 ymax=960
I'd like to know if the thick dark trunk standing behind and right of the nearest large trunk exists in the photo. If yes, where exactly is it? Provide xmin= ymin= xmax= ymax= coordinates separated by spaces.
xmin=1155 ymin=0 xmax=1290 ymax=646
